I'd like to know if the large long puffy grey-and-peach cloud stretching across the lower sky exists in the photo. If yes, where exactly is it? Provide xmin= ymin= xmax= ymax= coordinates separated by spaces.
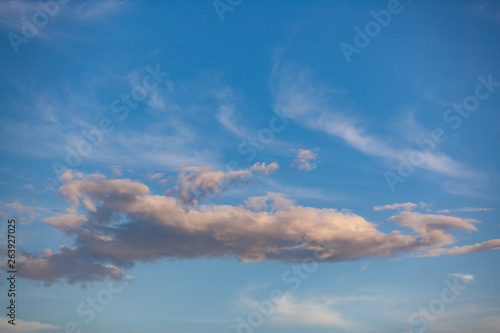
xmin=5 ymin=170 xmax=500 ymax=283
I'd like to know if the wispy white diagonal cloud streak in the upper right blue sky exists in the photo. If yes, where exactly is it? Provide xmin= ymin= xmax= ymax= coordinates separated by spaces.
xmin=271 ymin=64 xmax=473 ymax=177
